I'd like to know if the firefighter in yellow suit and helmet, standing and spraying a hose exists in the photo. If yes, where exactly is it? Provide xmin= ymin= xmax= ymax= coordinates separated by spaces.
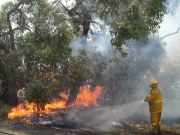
xmin=145 ymin=79 xmax=163 ymax=134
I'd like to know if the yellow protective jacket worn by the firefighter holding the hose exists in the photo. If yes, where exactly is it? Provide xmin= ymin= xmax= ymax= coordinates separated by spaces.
xmin=146 ymin=88 xmax=163 ymax=113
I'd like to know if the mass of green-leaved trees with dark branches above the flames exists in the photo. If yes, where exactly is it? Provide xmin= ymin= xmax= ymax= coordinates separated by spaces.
xmin=0 ymin=0 xmax=166 ymax=104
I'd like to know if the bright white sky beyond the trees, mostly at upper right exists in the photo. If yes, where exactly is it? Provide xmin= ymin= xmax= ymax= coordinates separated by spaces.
xmin=0 ymin=0 xmax=180 ymax=60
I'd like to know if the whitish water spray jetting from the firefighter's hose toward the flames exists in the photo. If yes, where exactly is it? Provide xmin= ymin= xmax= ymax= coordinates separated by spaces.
xmin=68 ymin=101 xmax=146 ymax=131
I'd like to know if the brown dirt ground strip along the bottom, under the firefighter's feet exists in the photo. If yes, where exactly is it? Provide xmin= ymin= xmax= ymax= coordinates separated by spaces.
xmin=0 ymin=118 xmax=180 ymax=135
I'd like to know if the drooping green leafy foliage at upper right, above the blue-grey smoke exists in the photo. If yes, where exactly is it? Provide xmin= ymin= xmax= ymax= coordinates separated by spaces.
xmin=111 ymin=0 xmax=166 ymax=51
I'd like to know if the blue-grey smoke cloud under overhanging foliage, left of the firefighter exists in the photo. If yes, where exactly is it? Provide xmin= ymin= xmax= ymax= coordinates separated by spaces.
xmin=103 ymin=36 xmax=165 ymax=104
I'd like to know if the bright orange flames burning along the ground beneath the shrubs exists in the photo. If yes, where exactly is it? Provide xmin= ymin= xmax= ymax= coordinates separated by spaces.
xmin=8 ymin=86 xmax=104 ymax=121
